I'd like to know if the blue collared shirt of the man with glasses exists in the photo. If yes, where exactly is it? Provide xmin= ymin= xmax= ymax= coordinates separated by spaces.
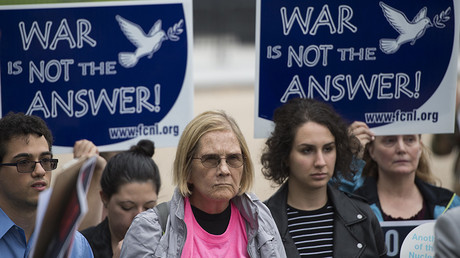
xmin=0 ymin=208 xmax=94 ymax=258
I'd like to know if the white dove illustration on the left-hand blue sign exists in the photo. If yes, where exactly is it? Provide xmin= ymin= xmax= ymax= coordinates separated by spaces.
xmin=115 ymin=15 xmax=168 ymax=68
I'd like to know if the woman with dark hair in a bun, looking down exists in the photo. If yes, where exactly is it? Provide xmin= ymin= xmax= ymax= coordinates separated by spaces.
xmin=82 ymin=140 xmax=161 ymax=258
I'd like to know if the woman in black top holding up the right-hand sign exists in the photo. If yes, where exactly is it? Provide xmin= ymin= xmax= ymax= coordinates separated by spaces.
xmin=350 ymin=122 xmax=460 ymax=221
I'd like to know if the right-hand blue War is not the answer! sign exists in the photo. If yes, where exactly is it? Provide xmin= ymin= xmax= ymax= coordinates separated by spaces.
xmin=255 ymin=0 xmax=459 ymax=137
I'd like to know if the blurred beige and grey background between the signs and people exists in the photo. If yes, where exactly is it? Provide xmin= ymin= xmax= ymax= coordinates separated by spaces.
xmin=0 ymin=0 xmax=459 ymax=202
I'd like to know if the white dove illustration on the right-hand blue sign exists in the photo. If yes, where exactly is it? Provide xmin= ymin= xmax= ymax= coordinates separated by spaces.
xmin=380 ymin=2 xmax=433 ymax=54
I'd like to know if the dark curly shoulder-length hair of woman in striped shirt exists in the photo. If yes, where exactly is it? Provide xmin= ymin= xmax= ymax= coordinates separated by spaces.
xmin=261 ymin=98 xmax=360 ymax=184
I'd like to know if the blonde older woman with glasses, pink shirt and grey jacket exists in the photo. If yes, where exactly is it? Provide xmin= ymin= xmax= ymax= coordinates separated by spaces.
xmin=121 ymin=111 xmax=286 ymax=258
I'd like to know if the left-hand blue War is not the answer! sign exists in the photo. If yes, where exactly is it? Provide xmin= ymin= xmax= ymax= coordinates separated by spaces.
xmin=0 ymin=0 xmax=193 ymax=152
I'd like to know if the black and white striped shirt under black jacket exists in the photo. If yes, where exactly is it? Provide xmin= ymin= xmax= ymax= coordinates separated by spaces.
xmin=287 ymin=203 xmax=334 ymax=257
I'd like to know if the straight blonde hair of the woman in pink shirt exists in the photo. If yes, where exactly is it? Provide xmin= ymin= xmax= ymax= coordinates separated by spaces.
xmin=173 ymin=110 xmax=254 ymax=197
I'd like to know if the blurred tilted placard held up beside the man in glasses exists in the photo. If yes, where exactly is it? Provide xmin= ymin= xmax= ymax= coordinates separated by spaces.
xmin=30 ymin=157 xmax=96 ymax=258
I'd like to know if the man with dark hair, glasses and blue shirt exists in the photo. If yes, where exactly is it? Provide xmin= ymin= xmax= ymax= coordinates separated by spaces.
xmin=0 ymin=113 xmax=93 ymax=258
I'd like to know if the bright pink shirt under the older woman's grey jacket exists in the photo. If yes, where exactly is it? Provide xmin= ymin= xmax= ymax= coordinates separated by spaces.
xmin=181 ymin=198 xmax=249 ymax=258
